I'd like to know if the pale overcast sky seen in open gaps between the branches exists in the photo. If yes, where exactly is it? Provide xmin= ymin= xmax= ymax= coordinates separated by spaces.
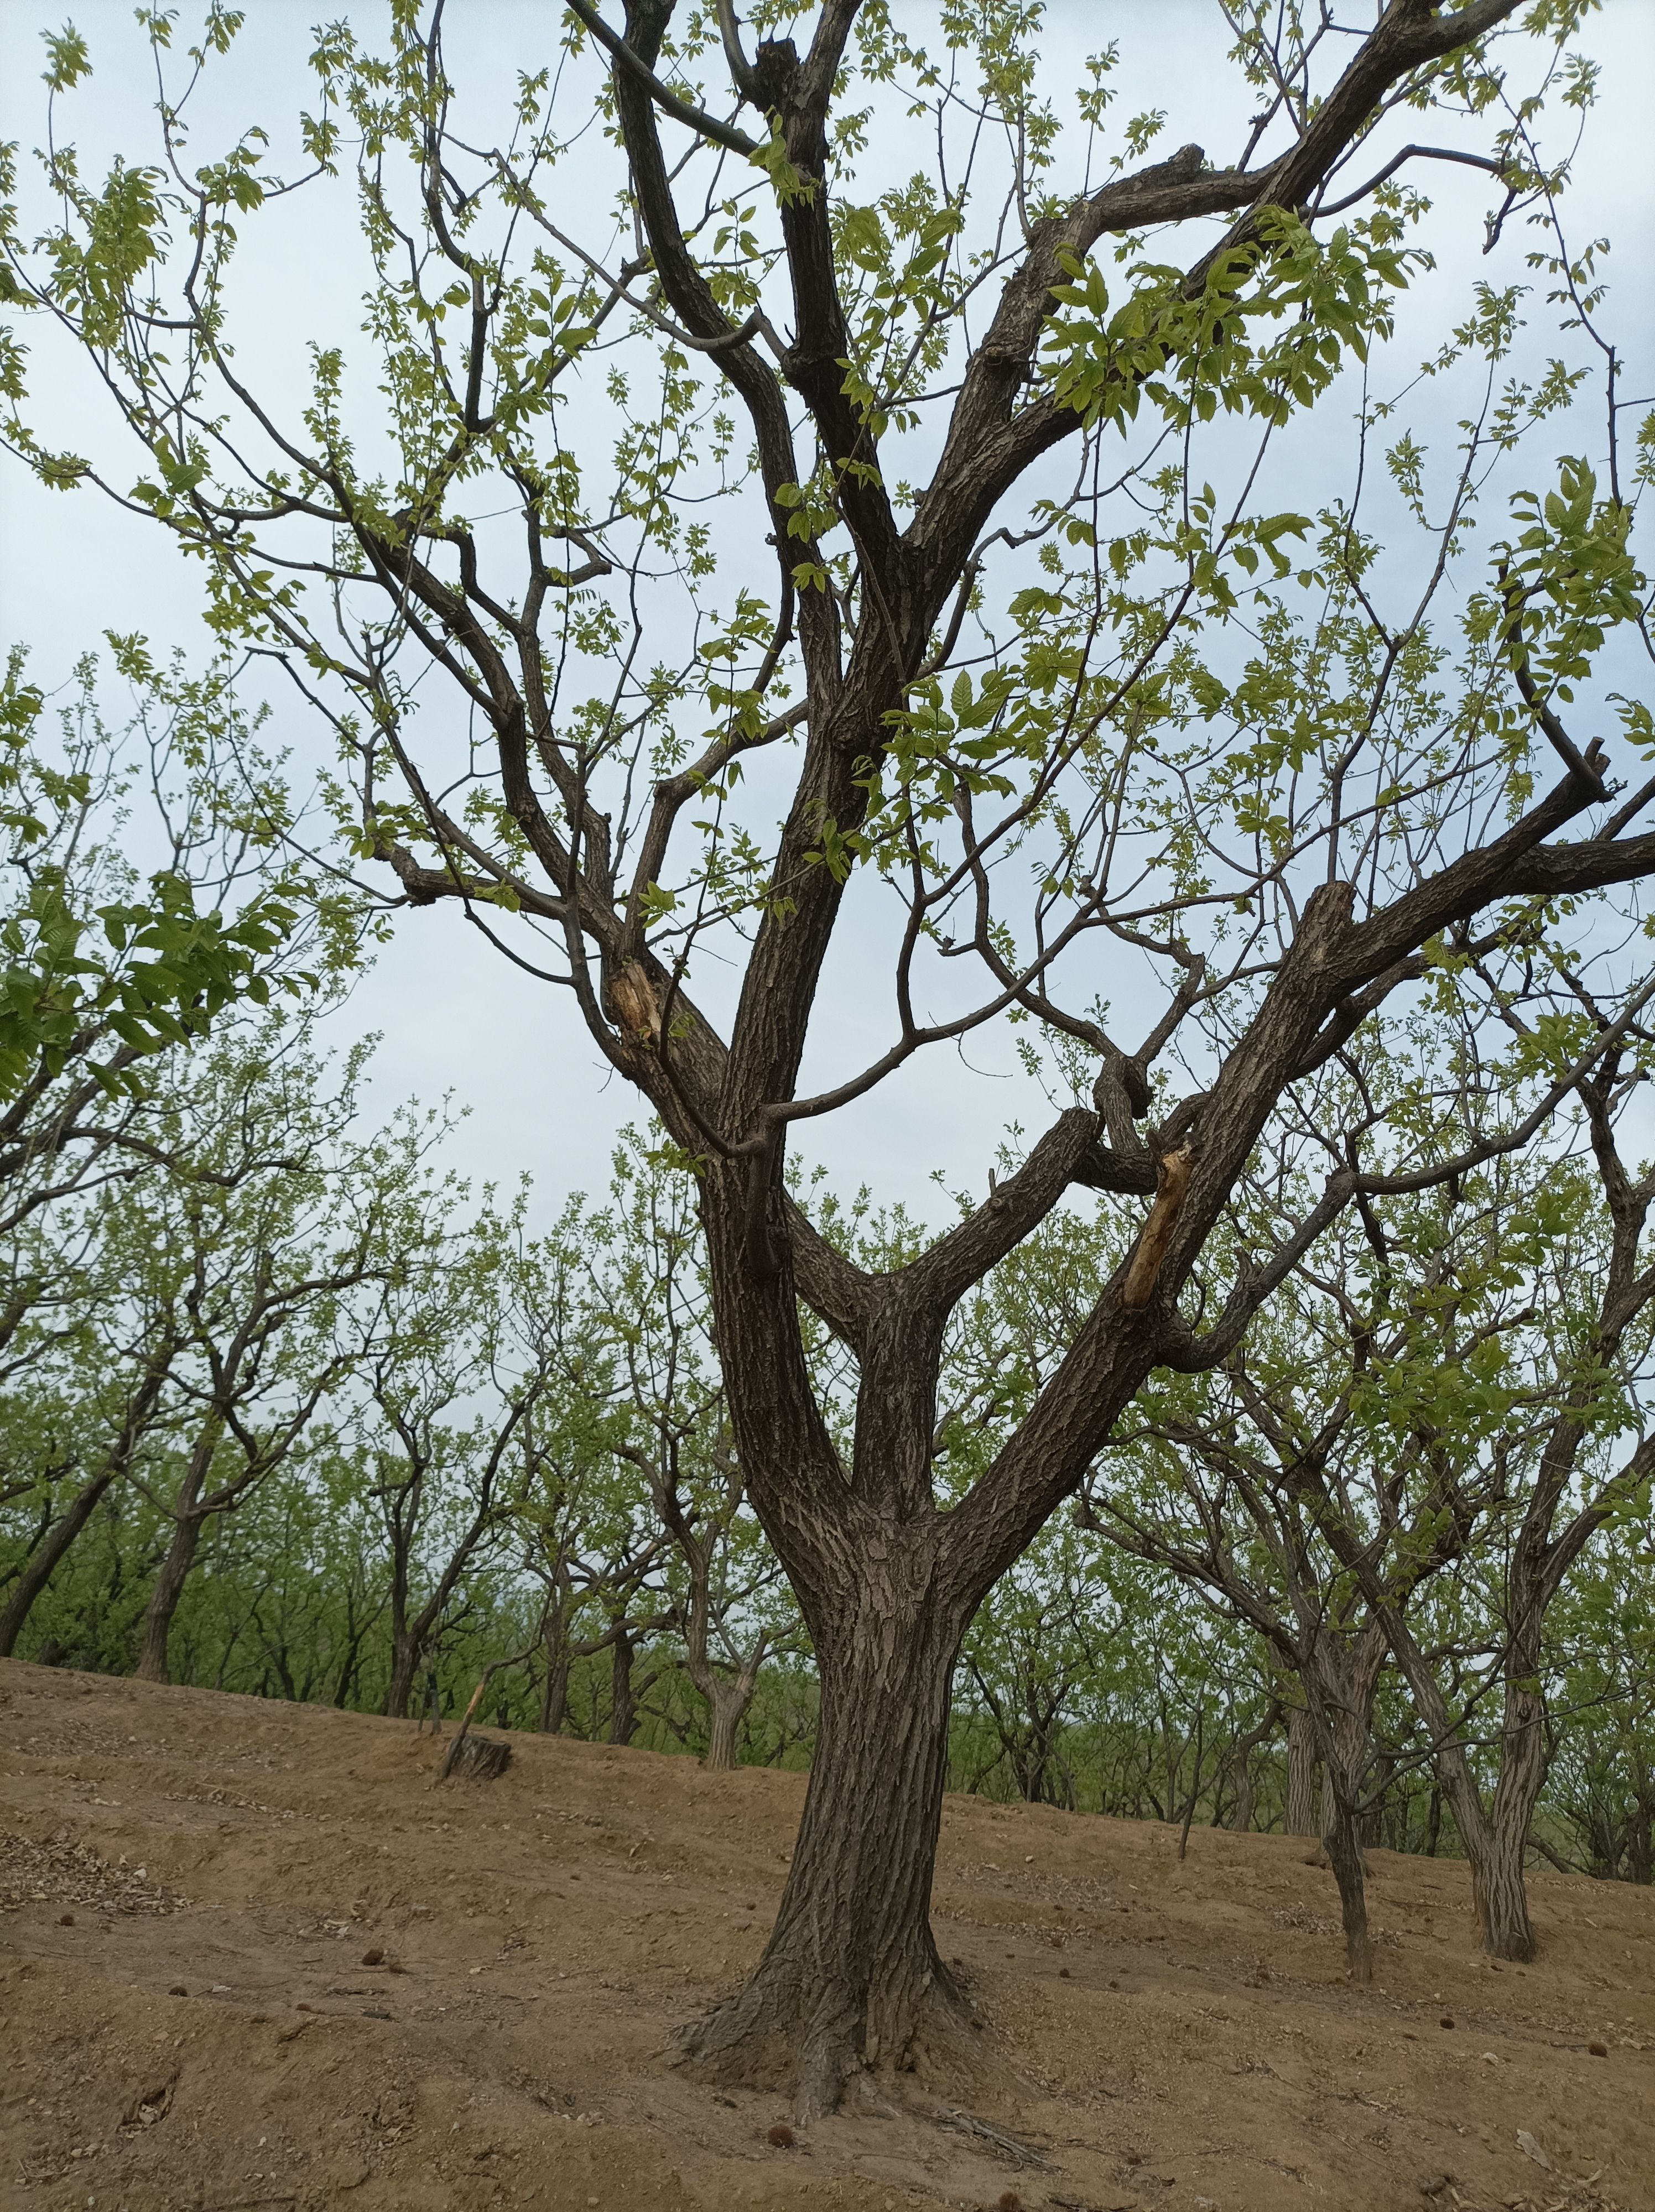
xmin=0 ymin=0 xmax=1655 ymax=1212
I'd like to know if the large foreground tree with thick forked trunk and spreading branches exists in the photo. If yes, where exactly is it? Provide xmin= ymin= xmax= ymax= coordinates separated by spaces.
xmin=0 ymin=0 xmax=1655 ymax=2110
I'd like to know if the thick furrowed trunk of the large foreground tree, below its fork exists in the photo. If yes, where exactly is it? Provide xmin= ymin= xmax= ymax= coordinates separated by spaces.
xmin=675 ymin=1588 xmax=967 ymax=2119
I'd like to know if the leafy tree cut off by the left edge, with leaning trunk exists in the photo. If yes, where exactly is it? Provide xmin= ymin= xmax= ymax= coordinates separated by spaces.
xmin=0 ymin=639 xmax=316 ymax=1652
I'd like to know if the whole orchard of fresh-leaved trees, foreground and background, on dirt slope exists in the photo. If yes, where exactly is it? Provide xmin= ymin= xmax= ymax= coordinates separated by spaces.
xmin=0 ymin=0 xmax=1655 ymax=2112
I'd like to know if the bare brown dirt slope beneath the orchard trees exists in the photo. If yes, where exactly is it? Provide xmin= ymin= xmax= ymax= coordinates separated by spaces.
xmin=0 ymin=1663 xmax=1655 ymax=2212
